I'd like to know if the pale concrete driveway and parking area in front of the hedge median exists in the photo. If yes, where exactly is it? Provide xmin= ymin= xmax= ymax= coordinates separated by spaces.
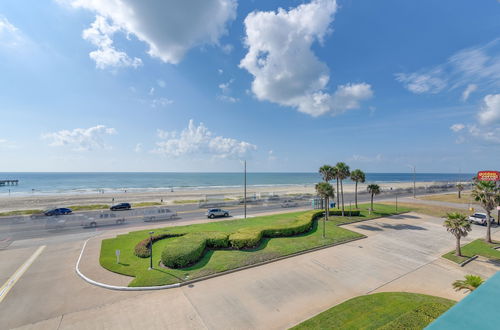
xmin=4 ymin=213 xmax=500 ymax=329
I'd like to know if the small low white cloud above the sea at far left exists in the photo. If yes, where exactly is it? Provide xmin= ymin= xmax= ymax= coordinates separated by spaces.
xmin=42 ymin=125 xmax=117 ymax=151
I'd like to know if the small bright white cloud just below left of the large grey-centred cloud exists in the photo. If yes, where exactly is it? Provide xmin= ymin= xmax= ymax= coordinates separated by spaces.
xmin=82 ymin=15 xmax=142 ymax=69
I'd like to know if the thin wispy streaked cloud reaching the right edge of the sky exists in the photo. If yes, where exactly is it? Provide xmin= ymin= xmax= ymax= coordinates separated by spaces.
xmin=395 ymin=39 xmax=500 ymax=95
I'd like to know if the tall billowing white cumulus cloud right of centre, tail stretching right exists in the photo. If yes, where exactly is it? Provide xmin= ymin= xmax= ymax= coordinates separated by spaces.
xmin=240 ymin=0 xmax=373 ymax=116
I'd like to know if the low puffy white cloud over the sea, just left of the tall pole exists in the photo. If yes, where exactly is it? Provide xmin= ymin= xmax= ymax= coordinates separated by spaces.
xmin=154 ymin=119 xmax=257 ymax=158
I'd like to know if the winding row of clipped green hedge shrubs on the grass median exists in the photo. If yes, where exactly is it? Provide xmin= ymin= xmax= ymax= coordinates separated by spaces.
xmin=134 ymin=211 xmax=323 ymax=269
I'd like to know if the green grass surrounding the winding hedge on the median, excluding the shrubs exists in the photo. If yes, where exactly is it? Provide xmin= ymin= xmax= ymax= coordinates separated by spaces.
xmin=100 ymin=204 xmax=408 ymax=286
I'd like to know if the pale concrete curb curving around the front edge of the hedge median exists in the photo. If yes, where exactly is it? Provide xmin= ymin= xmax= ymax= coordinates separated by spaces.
xmin=75 ymin=235 xmax=367 ymax=291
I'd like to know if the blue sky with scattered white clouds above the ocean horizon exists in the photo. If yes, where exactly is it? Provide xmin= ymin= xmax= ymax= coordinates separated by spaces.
xmin=0 ymin=0 xmax=500 ymax=172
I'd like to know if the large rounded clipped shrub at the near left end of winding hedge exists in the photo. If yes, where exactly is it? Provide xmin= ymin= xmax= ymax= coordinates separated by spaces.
xmin=161 ymin=234 xmax=207 ymax=268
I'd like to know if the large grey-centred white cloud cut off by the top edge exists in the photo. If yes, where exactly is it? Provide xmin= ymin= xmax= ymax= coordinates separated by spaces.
xmin=64 ymin=0 xmax=237 ymax=64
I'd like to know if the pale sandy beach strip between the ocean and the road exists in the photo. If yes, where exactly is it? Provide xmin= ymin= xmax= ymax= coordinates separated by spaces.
xmin=0 ymin=182 xmax=458 ymax=212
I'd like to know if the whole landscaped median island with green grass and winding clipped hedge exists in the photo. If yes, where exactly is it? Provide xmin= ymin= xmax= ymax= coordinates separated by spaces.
xmin=100 ymin=204 xmax=408 ymax=287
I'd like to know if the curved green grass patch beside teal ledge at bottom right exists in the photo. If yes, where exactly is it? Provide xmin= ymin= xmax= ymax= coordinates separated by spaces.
xmin=292 ymin=292 xmax=455 ymax=330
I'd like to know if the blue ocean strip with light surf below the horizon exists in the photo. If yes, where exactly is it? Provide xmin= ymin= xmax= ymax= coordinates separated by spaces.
xmin=0 ymin=172 xmax=474 ymax=196
